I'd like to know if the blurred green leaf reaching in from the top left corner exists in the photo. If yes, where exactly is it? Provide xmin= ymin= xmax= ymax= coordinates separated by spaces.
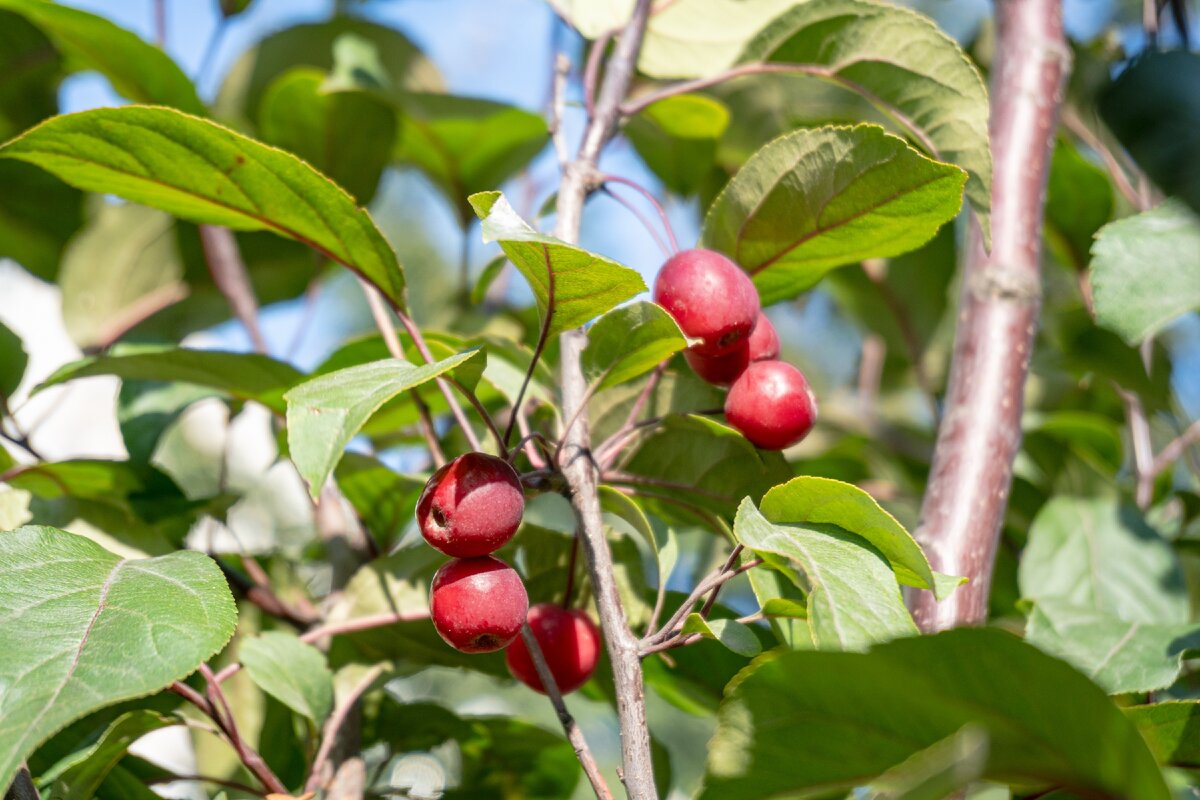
xmin=0 ymin=0 xmax=208 ymax=115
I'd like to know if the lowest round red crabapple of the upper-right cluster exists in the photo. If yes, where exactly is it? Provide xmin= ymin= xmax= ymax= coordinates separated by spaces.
xmin=725 ymin=361 xmax=817 ymax=450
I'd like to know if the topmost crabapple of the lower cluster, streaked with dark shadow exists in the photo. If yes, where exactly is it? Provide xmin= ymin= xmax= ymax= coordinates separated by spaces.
xmin=416 ymin=452 xmax=524 ymax=558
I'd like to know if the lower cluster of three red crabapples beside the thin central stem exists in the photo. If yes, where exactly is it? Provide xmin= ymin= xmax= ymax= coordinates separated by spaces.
xmin=416 ymin=452 xmax=600 ymax=693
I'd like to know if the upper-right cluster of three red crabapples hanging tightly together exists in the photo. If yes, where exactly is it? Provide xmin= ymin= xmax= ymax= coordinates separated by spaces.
xmin=654 ymin=248 xmax=817 ymax=450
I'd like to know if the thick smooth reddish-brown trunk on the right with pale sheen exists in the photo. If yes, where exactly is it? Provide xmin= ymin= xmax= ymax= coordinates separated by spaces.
xmin=912 ymin=0 xmax=1070 ymax=631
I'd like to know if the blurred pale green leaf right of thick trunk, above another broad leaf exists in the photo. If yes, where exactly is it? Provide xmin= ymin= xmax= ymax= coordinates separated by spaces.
xmin=1020 ymin=497 xmax=1189 ymax=625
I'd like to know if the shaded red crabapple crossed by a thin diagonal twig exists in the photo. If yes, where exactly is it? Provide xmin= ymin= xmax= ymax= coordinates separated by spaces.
xmin=504 ymin=603 xmax=600 ymax=694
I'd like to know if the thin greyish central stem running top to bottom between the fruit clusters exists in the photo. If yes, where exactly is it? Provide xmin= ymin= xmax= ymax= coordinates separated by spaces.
xmin=554 ymin=0 xmax=658 ymax=800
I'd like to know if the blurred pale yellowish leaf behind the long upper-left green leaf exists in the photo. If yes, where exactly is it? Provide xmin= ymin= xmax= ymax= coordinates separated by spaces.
xmin=59 ymin=204 xmax=187 ymax=348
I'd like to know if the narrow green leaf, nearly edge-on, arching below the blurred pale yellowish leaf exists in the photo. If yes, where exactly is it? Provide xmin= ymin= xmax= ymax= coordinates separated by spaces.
xmin=34 ymin=348 xmax=304 ymax=411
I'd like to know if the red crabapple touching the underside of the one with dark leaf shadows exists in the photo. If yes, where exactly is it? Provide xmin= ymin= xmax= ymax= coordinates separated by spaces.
xmin=430 ymin=555 xmax=529 ymax=652
